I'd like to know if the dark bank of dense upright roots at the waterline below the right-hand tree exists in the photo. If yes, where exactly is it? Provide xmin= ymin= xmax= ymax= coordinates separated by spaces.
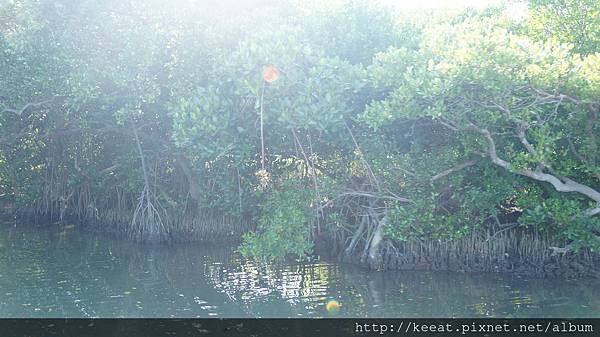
xmin=317 ymin=230 xmax=600 ymax=278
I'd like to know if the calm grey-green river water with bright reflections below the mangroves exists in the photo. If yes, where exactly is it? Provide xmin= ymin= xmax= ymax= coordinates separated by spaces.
xmin=0 ymin=227 xmax=600 ymax=318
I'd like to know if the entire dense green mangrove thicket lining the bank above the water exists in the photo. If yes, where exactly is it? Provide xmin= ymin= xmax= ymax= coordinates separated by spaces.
xmin=0 ymin=0 xmax=600 ymax=266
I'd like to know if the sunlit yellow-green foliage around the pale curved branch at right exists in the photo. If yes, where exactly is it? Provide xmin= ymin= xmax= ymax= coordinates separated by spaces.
xmin=361 ymin=8 xmax=600 ymax=246
